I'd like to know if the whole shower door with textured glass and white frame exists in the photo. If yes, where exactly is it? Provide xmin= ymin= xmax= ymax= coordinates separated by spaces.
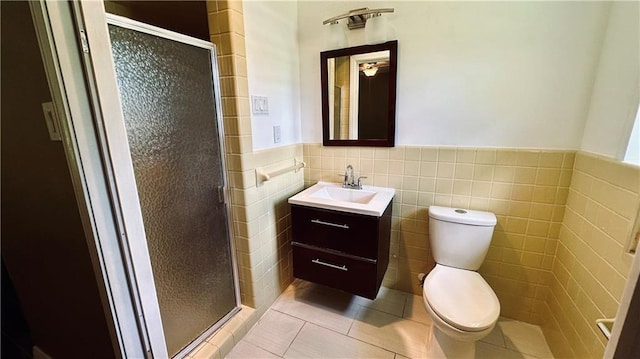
xmin=32 ymin=1 xmax=240 ymax=358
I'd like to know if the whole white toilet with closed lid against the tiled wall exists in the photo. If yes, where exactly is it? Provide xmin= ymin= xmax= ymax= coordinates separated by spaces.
xmin=422 ymin=206 xmax=500 ymax=358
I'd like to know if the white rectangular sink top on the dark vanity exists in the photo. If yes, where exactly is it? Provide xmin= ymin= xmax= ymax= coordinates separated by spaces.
xmin=289 ymin=182 xmax=396 ymax=217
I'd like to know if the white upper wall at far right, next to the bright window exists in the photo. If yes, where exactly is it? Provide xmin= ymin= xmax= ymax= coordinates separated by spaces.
xmin=581 ymin=2 xmax=640 ymax=160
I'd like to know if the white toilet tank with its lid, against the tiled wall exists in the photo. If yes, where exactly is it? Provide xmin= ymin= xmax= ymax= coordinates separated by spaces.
xmin=429 ymin=206 xmax=497 ymax=270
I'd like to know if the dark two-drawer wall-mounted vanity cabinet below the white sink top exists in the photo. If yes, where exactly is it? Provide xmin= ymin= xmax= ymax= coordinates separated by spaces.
xmin=291 ymin=202 xmax=393 ymax=299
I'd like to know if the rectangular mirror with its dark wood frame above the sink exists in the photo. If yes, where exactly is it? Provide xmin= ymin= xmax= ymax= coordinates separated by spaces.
xmin=320 ymin=41 xmax=398 ymax=147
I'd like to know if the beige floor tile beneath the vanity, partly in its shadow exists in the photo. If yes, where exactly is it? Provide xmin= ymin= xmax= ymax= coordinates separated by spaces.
xmin=271 ymin=285 xmax=360 ymax=334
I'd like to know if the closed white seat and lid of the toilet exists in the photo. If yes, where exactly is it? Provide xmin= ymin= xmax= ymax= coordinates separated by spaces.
xmin=423 ymin=264 xmax=500 ymax=332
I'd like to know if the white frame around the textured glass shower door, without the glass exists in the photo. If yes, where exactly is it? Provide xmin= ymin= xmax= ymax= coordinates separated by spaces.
xmin=32 ymin=0 xmax=240 ymax=358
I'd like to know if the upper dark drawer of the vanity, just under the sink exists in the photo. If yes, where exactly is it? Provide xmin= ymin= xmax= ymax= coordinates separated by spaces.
xmin=291 ymin=206 xmax=380 ymax=258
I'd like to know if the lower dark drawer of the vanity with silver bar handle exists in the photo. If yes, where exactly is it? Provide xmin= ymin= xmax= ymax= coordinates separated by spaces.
xmin=292 ymin=243 xmax=384 ymax=299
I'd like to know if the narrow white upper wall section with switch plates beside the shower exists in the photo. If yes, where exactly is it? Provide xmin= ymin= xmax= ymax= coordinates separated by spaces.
xmin=243 ymin=1 xmax=302 ymax=150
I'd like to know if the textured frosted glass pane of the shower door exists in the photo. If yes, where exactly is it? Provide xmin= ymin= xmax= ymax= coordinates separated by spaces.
xmin=109 ymin=25 xmax=236 ymax=356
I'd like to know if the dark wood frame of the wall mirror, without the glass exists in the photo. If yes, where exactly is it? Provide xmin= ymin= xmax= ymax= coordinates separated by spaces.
xmin=320 ymin=40 xmax=398 ymax=147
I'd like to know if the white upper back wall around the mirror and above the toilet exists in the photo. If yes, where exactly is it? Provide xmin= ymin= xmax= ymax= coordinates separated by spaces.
xmin=298 ymin=1 xmax=610 ymax=149
